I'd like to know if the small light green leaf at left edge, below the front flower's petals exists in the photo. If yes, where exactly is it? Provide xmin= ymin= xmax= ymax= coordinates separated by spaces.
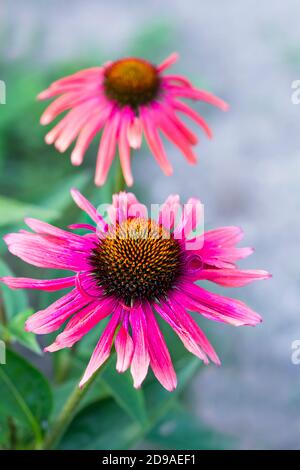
xmin=0 ymin=309 xmax=41 ymax=354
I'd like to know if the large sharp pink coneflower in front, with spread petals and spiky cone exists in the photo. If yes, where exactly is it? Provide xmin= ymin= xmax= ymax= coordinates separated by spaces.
xmin=1 ymin=189 xmax=269 ymax=391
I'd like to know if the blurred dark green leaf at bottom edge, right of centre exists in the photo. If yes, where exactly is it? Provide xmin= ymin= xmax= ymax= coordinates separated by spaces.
xmin=147 ymin=408 xmax=229 ymax=450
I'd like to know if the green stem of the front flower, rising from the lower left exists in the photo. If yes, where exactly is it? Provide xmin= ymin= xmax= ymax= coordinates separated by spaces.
xmin=38 ymin=373 xmax=97 ymax=450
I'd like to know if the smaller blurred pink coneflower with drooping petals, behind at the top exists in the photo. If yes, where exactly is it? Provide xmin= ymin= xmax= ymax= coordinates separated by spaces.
xmin=38 ymin=53 xmax=228 ymax=186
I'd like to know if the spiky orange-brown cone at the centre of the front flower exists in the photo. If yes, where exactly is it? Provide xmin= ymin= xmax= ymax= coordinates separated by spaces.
xmin=91 ymin=218 xmax=182 ymax=306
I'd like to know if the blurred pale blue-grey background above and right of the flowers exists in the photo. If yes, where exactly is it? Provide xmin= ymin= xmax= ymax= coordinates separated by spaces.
xmin=0 ymin=0 xmax=300 ymax=448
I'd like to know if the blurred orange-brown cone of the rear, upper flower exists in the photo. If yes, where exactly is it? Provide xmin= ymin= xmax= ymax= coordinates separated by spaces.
xmin=104 ymin=58 xmax=159 ymax=111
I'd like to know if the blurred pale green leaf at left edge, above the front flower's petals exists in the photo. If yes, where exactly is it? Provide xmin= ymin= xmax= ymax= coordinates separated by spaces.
xmin=0 ymin=196 xmax=59 ymax=226
